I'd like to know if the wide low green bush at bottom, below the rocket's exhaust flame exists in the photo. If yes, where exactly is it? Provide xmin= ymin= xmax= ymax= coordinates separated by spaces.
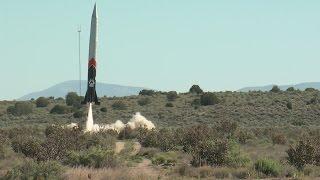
xmin=64 ymin=148 xmax=118 ymax=168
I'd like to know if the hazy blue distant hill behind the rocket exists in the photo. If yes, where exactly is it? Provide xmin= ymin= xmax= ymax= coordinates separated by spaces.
xmin=19 ymin=81 xmax=145 ymax=100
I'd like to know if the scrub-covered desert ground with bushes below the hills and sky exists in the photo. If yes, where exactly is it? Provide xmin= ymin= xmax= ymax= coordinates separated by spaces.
xmin=0 ymin=85 xmax=320 ymax=179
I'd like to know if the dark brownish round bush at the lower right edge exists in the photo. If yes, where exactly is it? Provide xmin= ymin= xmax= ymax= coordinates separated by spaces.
xmin=287 ymin=141 xmax=315 ymax=171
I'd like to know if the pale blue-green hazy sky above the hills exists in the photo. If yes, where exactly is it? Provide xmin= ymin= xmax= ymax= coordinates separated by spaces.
xmin=0 ymin=0 xmax=320 ymax=99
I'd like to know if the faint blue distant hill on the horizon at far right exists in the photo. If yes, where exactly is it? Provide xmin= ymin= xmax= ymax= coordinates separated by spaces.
xmin=238 ymin=82 xmax=320 ymax=92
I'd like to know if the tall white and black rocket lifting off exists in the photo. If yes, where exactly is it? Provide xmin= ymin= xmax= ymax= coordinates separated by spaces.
xmin=82 ymin=4 xmax=100 ymax=105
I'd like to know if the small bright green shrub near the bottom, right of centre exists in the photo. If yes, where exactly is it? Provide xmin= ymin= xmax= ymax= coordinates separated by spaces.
xmin=254 ymin=158 xmax=282 ymax=177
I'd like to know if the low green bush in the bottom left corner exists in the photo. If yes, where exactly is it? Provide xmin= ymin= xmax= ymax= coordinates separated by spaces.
xmin=3 ymin=160 xmax=64 ymax=180
